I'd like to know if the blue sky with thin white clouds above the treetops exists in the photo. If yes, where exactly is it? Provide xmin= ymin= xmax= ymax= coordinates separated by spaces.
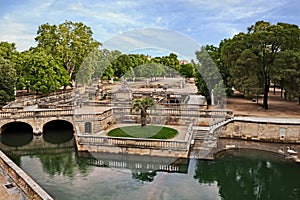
xmin=0 ymin=0 xmax=300 ymax=55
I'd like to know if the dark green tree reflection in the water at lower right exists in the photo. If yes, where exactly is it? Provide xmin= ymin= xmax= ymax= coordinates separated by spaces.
xmin=194 ymin=150 xmax=300 ymax=200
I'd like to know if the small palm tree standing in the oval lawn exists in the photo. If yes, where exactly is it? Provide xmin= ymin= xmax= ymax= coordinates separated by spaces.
xmin=131 ymin=97 xmax=154 ymax=127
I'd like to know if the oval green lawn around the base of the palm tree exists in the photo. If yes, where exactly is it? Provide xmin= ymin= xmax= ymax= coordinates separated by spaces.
xmin=108 ymin=125 xmax=178 ymax=139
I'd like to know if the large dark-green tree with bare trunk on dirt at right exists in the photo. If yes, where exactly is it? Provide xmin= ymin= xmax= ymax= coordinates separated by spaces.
xmin=221 ymin=21 xmax=300 ymax=109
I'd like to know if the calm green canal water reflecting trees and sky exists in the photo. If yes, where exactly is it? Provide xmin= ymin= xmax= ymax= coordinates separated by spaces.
xmin=0 ymin=127 xmax=300 ymax=200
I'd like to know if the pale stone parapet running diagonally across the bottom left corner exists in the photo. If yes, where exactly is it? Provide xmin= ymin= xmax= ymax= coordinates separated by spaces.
xmin=0 ymin=151 xmax=53 ymax=200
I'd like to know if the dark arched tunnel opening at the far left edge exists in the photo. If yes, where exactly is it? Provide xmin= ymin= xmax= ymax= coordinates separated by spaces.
xmin=0 ymin=122 xmax=33 ymax=147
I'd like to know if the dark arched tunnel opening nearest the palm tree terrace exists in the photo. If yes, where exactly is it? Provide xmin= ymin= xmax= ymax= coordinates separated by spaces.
xmin=43 ymin=120 xmax=74 ymax=144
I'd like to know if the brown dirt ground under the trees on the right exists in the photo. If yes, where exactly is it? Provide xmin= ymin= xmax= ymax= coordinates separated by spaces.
xmin=226 ymin=91 xmax=300 ymax=118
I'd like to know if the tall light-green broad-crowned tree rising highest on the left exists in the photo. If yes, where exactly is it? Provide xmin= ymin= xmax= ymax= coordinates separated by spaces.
xmin=35 ymin=21 xmax=100 ymax=80
